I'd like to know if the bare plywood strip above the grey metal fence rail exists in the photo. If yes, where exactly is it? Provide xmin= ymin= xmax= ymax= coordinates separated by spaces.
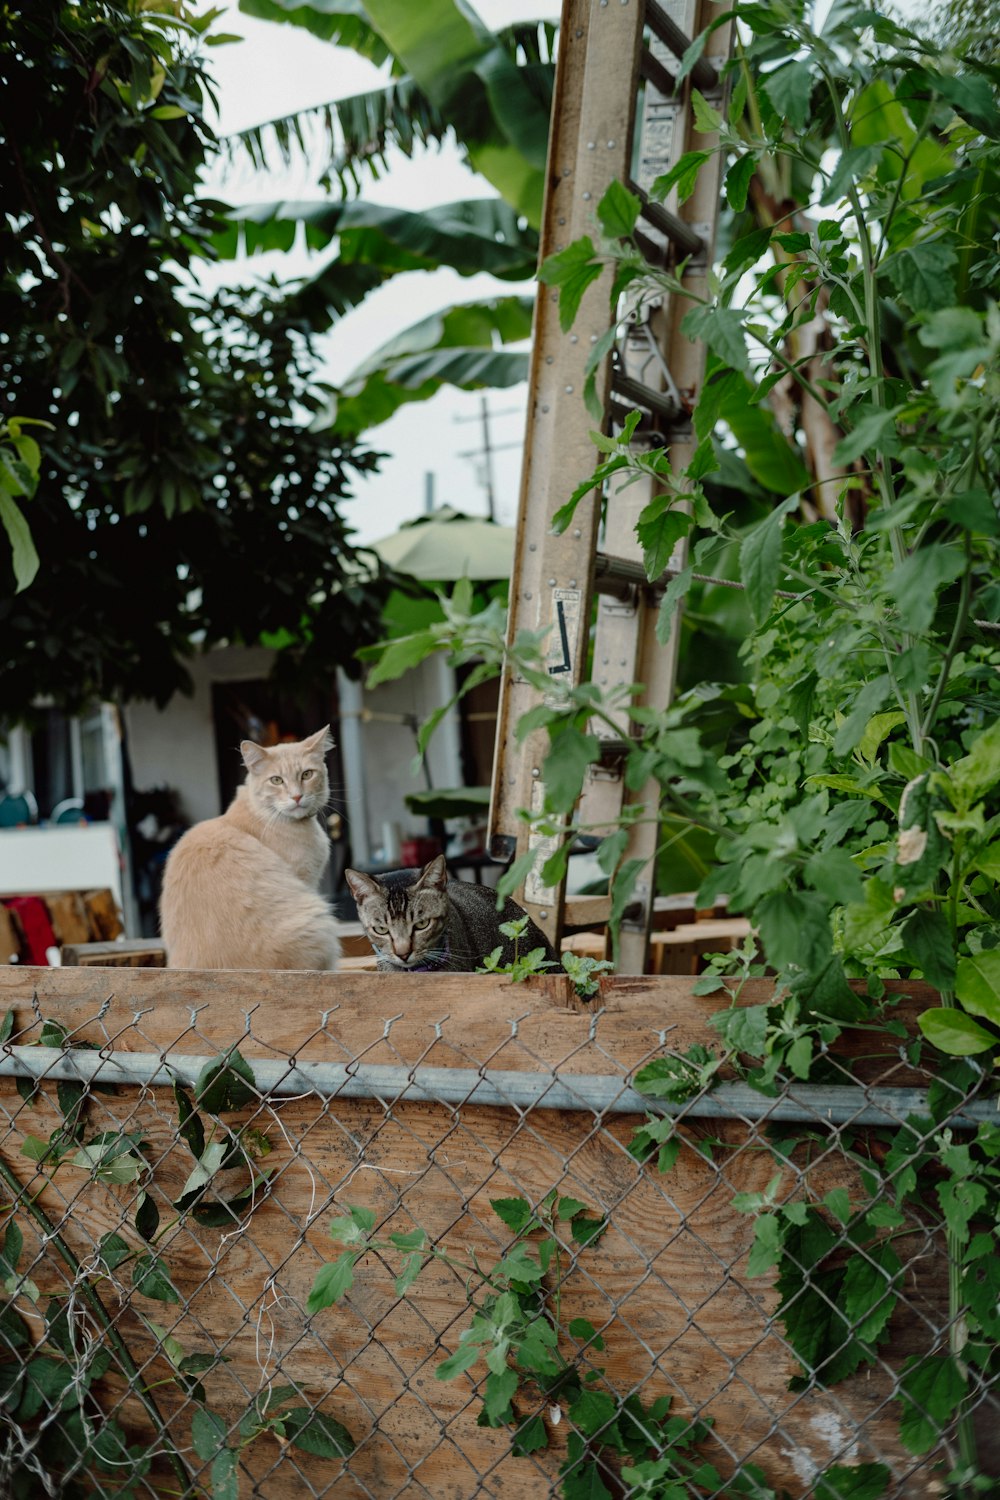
xmin=0 ymin=965 xmax=936 ymax=1083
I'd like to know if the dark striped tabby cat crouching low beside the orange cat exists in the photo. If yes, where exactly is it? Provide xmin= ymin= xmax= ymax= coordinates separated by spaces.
xmin=343 ymin=855 xmax=559 ymax=974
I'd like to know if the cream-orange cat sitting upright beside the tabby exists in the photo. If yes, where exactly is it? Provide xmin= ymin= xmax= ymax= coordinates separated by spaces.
xmin=160 ymin=726 xmax=340 ymax=969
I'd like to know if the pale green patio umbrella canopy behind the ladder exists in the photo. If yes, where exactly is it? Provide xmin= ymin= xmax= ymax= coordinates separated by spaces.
xmin=372 ymin=506 xmax=514 ymax=584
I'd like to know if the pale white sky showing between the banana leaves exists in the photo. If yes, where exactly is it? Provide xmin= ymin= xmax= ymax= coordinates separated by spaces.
xmin=193 ymin=0 xmax=559 ymax=542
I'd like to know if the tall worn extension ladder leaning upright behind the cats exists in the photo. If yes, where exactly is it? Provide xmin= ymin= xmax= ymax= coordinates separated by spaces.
xmin=489 ymin=0 xmax=732 ymax=974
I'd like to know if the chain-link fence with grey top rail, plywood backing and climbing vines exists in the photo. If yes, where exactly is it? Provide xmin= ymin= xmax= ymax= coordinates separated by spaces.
xmin=0 ymin=971 xmax=1000 ymax=1500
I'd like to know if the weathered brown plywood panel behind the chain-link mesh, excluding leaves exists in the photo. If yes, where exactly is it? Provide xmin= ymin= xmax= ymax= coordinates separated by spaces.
xmin=0 ymin=968 xmax=948 ymax=1500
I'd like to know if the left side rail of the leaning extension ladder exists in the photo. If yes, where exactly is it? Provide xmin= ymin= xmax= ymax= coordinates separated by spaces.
xmin=490 ymin=0 xmax=642 ymax=941
